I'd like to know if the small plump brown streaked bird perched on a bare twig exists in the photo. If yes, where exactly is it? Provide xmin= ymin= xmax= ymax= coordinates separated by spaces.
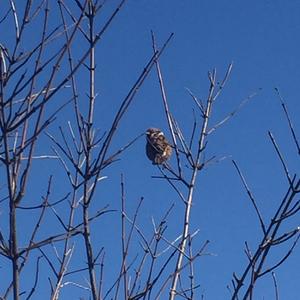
xmin=146 ymin=128 xmax=172 ymax=165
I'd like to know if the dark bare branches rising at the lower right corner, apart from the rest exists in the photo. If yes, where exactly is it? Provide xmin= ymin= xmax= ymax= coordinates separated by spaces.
xmin=232 ymin=89 xmax=300 ymax=299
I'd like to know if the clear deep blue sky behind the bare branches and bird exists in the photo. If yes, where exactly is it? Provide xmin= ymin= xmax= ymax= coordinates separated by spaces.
xmin=0 ymin=0 xmax=300 ymax=300
